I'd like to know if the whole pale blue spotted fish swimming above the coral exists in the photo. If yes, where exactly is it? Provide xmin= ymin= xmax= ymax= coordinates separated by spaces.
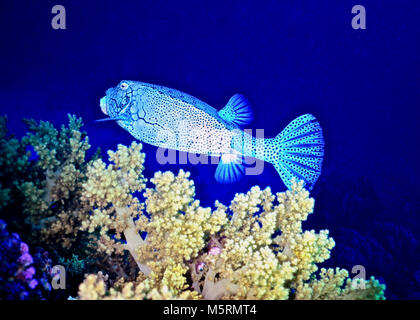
xmin=98 ymin=81 xmax=324 ymax=188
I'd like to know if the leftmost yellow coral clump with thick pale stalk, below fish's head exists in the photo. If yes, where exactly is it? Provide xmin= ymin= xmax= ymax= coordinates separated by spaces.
xmin=81 ymin=142 xmax=148 ymax=273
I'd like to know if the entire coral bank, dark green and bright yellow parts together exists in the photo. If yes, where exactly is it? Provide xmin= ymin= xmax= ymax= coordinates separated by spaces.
xmin=0 ymin=116 xmax=385 ymax=299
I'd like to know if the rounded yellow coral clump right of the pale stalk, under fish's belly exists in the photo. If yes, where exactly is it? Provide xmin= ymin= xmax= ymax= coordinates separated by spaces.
xmin=138 ymin=170 xmax=227 ymax=275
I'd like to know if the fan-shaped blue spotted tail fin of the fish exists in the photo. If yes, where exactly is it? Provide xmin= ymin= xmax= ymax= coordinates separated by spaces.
xmin=269 ymin=114 xmax=324 ymax=190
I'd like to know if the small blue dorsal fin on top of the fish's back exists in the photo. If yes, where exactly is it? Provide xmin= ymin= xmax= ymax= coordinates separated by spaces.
xmin=219 ymin=94 xmax=254 ymax=126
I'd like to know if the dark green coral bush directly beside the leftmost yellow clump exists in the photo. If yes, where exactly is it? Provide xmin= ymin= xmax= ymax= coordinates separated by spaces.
xmin=20 ymin=115 xmax=90 ymax=248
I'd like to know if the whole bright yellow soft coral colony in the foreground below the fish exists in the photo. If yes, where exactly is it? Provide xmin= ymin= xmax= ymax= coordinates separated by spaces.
xmin=79 ymin=143 xmax=384 ymax=299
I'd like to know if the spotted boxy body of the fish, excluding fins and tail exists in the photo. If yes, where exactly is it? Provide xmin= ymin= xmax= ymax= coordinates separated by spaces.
xmin=106 ymin=81 xmax=234 ymax=155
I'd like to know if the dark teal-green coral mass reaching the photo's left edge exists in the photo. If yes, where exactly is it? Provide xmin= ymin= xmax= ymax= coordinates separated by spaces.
xmin=0 ymin=115 xmax=94 ymax=248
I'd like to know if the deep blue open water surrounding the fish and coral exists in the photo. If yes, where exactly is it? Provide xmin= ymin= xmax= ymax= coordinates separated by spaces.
xmin=0 ymin=0 xmax=420 ymax=299
